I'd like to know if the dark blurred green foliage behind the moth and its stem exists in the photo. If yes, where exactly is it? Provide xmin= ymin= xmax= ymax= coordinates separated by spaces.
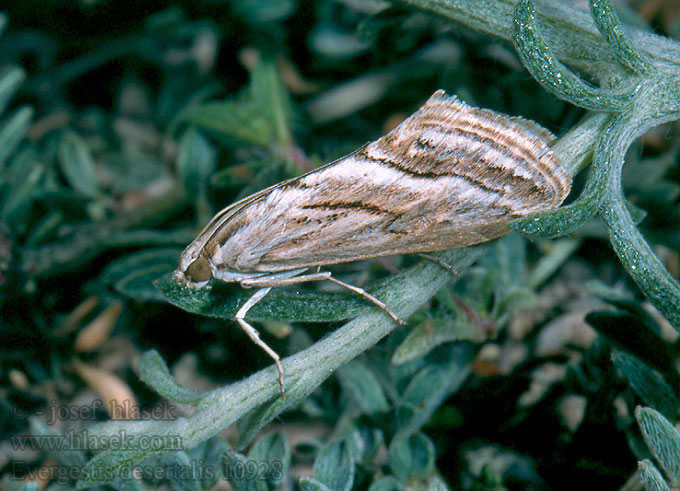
xmin=0 ymin=0 xmax=680 ymax=490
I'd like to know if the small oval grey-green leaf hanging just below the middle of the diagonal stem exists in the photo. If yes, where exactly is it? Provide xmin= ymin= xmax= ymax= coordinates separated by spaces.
xmin=338 ymin=361 xmax=390 ymax=414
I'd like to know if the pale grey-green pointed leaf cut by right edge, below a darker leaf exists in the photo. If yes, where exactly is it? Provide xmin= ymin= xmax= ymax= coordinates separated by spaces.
xmin=635 ymin=407 xmax=680 ymax=482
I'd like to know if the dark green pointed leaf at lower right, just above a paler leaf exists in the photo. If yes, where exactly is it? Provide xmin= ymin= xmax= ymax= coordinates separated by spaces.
xmin=612 ymin=351 xmax=680 ymax=420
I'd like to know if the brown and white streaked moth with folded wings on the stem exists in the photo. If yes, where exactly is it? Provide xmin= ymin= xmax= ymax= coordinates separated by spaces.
xmin=175 ymin=90 xmax=571 ymax=395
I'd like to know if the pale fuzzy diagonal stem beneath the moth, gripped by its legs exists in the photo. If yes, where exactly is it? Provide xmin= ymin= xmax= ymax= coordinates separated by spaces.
xmin=80 ymin=246 xmax=486 ymax=486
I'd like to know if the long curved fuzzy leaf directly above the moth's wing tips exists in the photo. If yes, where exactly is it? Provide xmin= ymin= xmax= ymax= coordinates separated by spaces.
xmin=512 ymin=0 xmax=637 ymax=111
